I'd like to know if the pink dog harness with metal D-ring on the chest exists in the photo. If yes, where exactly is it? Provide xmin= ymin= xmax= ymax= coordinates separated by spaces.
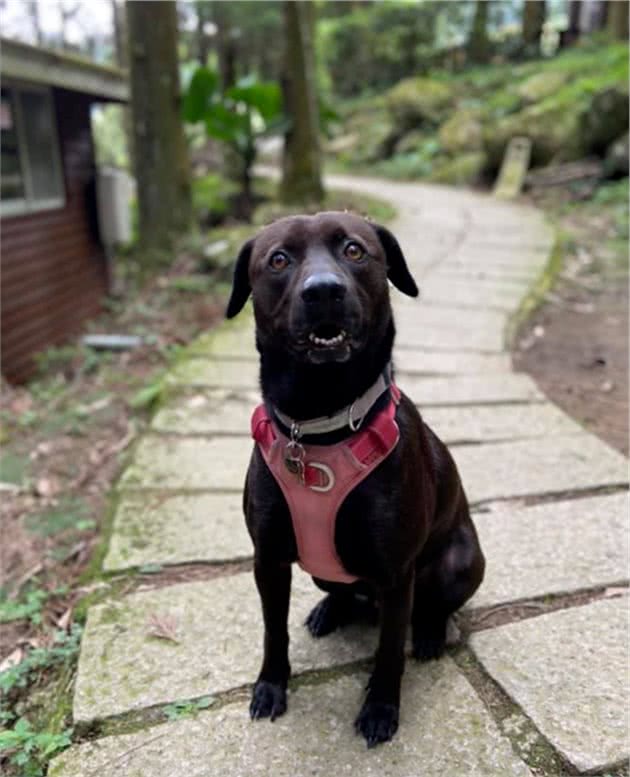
xmin=252 ymin=384 xmax=400 ymax=583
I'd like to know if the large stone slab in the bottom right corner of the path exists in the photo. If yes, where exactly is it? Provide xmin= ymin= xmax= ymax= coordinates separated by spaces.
xmin=472 ymin=596 xmax=630 ymax=771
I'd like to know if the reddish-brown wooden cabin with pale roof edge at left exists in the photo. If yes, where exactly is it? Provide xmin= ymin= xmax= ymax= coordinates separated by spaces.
xmin=0 ymin=39 xmax=129 ymax=383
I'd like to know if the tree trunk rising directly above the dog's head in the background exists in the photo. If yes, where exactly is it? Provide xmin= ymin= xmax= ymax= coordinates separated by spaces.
xmin=280 ymin=0 xmax=324 ymax=202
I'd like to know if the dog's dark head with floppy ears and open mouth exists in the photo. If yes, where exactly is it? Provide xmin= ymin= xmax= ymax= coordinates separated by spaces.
xmin=227 ymin=212 xmax=418 ymax=364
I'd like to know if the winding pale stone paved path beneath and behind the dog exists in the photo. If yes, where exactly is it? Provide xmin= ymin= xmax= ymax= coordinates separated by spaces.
xmin=50 ymin=179 xmax=628 ymax=777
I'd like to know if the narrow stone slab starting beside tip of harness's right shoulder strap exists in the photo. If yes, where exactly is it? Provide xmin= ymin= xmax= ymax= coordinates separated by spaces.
xmin=398 ymin=373 xmax=544 ymax=407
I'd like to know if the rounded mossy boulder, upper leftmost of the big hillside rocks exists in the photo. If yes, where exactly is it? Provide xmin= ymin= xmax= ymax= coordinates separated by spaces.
xmin=386 ymin=78 xmax=454 ymax=132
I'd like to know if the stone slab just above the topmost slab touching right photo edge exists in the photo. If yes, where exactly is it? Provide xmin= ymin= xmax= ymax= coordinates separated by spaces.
xmin=422 ymin=403 xmax=584 ymax=445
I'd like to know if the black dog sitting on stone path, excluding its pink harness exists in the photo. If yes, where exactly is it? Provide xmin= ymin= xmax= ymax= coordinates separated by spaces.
xmin=227 ymin=212 xmax=484 ymax=746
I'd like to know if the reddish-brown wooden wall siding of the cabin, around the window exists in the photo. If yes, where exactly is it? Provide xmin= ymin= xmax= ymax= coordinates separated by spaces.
xmin=0 ymin=90 xmax=106 ymax=383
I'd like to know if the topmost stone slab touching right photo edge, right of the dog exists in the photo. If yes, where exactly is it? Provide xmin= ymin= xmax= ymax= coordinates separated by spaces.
xmin=450 ymin=434 xmax=628 ymax=503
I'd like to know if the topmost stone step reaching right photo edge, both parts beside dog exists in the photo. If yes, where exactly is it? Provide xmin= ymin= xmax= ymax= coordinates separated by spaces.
xmin=119 ymin=434 xmax=628 ymax=503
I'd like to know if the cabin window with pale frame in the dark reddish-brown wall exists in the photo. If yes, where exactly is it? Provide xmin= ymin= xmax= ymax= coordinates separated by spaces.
xmin=0 ymin=86 xmax=64 ymax=216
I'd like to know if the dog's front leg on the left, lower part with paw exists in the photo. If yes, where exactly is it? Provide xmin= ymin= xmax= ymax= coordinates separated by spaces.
xmin=249 ymin=560 xmax=291 ymax=721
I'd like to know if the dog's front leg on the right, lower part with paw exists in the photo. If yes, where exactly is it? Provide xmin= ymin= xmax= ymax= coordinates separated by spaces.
xmin=355 ymin=565 xmax=414 ymax=747
